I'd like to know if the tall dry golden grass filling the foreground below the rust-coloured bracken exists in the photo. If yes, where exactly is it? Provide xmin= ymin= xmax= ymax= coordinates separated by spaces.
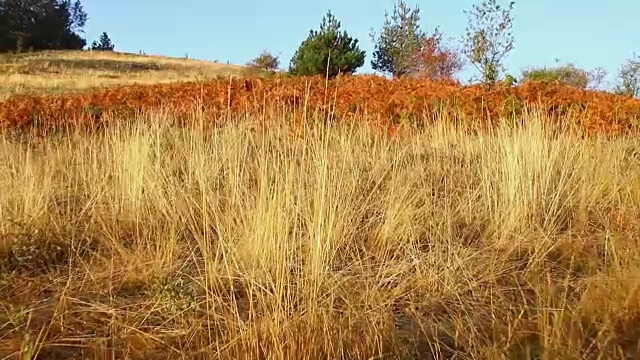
xmin=0 ymin=113 xmax=640 ymax=359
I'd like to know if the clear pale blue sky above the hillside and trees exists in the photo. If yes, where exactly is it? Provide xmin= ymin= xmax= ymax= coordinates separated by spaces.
xmin=83 ymin=0 xmax=640 ymax=87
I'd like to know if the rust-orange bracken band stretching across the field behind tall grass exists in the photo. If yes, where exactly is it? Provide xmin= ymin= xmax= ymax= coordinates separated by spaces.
xmin=0 ymin=75 xmax=640 ymax=135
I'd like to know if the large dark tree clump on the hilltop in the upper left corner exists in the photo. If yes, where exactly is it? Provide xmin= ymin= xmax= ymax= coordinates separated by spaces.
xmin=0 ymin=0 xmax=87 ymax=52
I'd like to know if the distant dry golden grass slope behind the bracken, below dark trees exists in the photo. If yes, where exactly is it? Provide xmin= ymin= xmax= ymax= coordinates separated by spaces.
xmin=0 ymin=51 xmax=244 ymax=100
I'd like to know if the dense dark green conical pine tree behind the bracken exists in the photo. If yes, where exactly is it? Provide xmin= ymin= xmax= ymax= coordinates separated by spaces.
xmin=289 ymin=11 xmax=365 ymax=78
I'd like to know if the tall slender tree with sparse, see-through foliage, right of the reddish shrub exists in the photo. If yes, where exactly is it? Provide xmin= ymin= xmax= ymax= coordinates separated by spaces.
xmin=463 ymin=0 xmax=515 ymax=86
